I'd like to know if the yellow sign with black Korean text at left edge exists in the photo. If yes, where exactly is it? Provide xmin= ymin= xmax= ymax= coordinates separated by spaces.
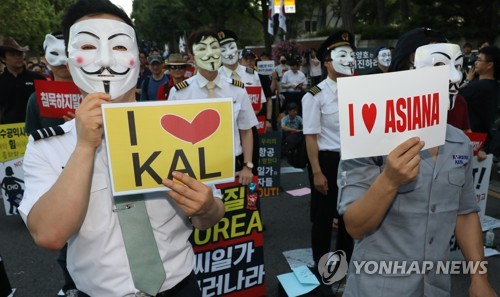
xmin=0 ymin=123 xmax=29 ymax=162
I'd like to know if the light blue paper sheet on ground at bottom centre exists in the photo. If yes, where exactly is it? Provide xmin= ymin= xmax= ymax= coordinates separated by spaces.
xmin=278 ymin=265 xmax=319 ymax=297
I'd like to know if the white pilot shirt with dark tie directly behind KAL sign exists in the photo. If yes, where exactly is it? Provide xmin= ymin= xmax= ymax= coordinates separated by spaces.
xmin=168 ymin=73 xmax=258 ymax=157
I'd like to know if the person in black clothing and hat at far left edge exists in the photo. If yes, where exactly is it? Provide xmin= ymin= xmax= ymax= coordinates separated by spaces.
xmin=0 ymin=37 xmax=45 ymax=124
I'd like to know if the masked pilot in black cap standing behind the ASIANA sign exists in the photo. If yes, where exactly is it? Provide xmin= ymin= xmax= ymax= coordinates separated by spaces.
xmin=302 ymin=30 xmax=355 ymax=296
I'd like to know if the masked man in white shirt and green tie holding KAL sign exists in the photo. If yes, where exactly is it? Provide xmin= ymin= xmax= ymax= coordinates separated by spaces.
xmin=19 ymin=0 xmax=225 ymax=297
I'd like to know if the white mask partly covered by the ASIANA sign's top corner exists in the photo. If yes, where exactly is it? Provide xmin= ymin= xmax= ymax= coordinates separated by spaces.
xmin=415 ymin=43 xmax=463 ymax=110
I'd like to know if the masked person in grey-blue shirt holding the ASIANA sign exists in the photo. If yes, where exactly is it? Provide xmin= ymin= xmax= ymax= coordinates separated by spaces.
xmin=337 ymin=28 xmax=496 ymax=297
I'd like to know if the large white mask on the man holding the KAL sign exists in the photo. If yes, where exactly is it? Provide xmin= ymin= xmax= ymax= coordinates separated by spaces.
xmin=68 ymin=19 xmax=139 ymax=100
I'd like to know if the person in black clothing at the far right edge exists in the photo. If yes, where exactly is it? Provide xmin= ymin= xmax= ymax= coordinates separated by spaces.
xmin=459 ymin=46 xmax=500 ymax=160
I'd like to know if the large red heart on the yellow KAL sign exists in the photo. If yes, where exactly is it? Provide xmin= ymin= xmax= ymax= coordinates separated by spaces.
xmin=161 ymin=109 xmax=220 ymax=144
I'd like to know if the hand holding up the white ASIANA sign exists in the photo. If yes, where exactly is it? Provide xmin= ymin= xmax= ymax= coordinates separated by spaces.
xmin=382 ymin=137 xmax=424 ymax=189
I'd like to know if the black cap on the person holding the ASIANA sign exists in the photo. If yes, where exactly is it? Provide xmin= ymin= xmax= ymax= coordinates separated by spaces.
xmin=389 ymin=27 xmax=448 ymax=71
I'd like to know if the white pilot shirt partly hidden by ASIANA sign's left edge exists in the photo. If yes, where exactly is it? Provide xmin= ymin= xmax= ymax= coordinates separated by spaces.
xmin=302 ymin=78 xmax=340 ymax=152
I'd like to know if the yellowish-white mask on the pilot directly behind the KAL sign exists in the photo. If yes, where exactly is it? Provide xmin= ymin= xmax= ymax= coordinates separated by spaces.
xmin=193 ymin=36 xmax=222 ymax=71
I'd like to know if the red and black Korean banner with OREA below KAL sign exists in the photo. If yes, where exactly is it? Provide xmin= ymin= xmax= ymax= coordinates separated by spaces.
xmin=191 ymin=176 xmax=266 ymax=297
